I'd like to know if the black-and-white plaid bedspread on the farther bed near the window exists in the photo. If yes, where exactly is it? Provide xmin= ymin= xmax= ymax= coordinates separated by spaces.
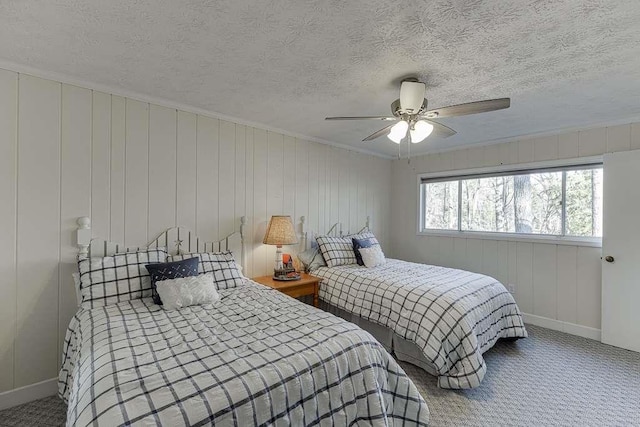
xmin=312 ymin=259 xmax=527 ymax=389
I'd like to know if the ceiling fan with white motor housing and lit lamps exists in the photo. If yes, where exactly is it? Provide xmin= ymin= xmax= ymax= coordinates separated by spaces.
xmin=325 ymin=78 xmax=511 ymax=144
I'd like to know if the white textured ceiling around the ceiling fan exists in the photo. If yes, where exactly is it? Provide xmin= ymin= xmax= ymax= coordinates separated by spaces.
xmin=0 ymin=0 xmax=640 ymax=155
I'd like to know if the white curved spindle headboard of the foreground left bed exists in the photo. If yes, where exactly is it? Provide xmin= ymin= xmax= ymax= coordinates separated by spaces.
xmin=77 ymin=216 xmax=247 ymax=266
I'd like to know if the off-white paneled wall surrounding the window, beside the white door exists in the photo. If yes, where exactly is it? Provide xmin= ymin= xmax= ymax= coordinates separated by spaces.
xmin=391 ymin=124 xmax=640 ymax=336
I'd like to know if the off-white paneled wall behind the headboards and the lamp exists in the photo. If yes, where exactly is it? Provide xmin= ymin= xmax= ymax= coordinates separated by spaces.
xmin=0 ymin=70 xmax=391 ymax=391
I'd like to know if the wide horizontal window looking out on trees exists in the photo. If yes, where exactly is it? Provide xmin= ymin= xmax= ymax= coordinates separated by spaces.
xmin=420 ymin=164 xmax=602 ymax=237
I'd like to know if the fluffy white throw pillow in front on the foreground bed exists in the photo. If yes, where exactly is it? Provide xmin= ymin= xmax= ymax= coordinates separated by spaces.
xmin=156 ymin=273 xmax=220 ymax=310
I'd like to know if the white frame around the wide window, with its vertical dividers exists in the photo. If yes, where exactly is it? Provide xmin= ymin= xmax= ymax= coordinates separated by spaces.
xmin=416 ymin=156 xmax=603 ymax=247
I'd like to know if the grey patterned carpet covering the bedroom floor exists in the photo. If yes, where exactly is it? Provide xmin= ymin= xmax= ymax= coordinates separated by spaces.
xmin=0 ymin=326 xmax=640 ymax=427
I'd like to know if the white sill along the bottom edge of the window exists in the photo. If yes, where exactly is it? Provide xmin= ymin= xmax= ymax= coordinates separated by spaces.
xmin=417 ymin=230 xmax=602 ymax=248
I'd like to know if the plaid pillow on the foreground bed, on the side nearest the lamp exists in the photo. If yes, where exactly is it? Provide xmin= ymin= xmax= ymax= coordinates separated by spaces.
xmin=167 ymin=251 xmax=244 ymax=289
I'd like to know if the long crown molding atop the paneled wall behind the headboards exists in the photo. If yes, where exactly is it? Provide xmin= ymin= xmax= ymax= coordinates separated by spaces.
xmin=0 ymin=59 xmax=396 ymax=160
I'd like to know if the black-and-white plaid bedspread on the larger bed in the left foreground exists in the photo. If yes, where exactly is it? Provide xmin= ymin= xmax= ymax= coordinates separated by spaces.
xmin=59 ymin=281 xmax=429 ymax=426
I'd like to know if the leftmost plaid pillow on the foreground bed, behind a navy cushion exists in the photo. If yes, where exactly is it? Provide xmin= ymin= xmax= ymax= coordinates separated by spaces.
xmin=78 ymin=248 xmax=167 ymax=308
